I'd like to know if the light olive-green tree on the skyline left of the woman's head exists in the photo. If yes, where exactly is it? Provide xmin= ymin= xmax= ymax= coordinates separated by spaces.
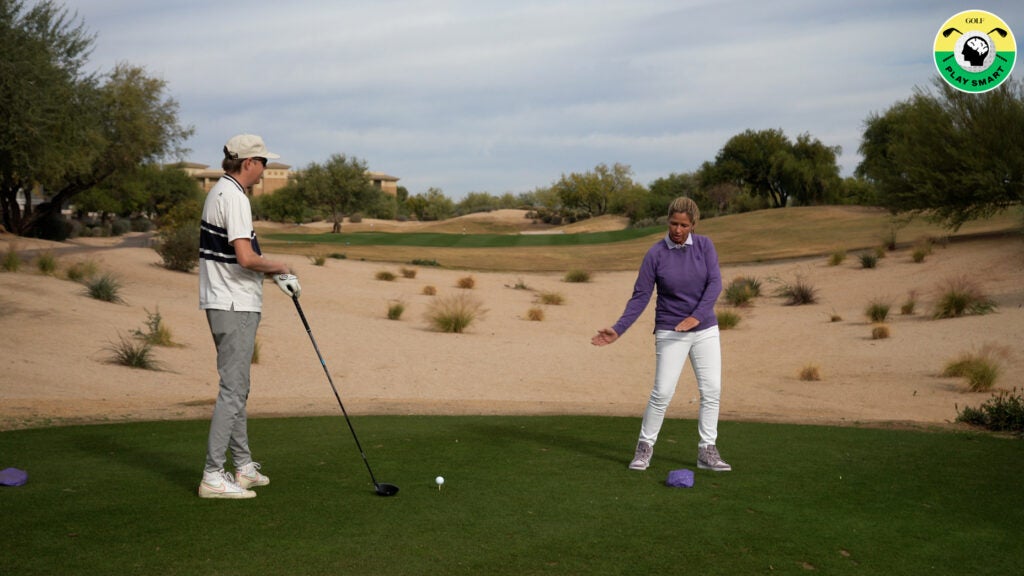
xmin=551 ymin=163 xmax=645 ymax=216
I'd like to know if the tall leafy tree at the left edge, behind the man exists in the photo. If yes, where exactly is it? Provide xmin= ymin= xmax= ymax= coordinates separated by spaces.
xmin=0 ymin=0 xmax=193 ymax=235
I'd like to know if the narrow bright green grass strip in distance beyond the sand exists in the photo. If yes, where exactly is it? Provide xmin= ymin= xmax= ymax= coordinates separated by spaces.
xmin=264 ymin=227 xmax=663 ymax=248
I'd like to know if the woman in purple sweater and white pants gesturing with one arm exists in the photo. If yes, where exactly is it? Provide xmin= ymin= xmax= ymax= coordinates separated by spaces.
xmin=591 ymin=197 xmax=732 ymax=471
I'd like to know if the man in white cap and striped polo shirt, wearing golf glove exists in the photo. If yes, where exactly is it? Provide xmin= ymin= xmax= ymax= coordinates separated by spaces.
xmin=199 ymin=134 xmax=301 ymax=498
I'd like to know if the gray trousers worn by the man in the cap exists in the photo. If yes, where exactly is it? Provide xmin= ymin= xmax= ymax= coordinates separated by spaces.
xmin=204 ymin=310 xmax=260 ymax=472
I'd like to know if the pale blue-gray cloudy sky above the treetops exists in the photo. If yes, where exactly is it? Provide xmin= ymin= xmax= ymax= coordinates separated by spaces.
xmin=74 ymin=0 xmax=1024 ymax=200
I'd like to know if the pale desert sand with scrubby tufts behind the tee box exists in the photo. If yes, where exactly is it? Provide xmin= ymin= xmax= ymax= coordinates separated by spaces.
xmin=0 ymin=214 xmax=1024 ymax=429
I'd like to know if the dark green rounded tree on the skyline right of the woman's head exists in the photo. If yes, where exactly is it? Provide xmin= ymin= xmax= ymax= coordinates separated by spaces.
xmin=701 ymin=129 xmax=842 ymax=208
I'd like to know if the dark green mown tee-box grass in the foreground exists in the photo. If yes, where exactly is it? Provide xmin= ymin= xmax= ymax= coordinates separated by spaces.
xmin=0 ymin=416 xmax=1024 ymax=576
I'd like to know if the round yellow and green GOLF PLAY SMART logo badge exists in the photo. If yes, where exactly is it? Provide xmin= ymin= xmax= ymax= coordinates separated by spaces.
xmin=935 ymin=10 xmax=1017 ymax=93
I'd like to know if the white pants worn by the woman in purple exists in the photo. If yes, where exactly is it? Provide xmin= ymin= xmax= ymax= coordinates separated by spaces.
xmin=640 ymin=326 xmax=722 ymax=447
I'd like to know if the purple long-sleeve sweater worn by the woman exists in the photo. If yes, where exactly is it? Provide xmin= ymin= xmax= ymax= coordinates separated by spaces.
xmin=611 ymin=233 xmax=722 ymax=336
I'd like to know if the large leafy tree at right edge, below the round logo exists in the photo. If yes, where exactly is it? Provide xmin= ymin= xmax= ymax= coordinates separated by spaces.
xmin=856 ymin=78 xmax=1024 ymax=231
